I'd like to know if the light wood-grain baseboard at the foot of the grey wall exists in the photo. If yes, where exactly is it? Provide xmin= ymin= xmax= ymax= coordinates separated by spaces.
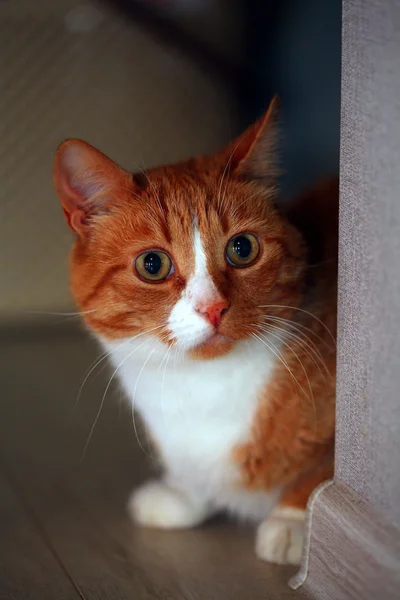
xmin=292 ymin=483 xmax=400 ymax=600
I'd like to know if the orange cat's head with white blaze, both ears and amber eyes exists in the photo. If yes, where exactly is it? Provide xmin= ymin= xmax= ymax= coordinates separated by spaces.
xmin=54 ymin=100 xmax=305 ymax=359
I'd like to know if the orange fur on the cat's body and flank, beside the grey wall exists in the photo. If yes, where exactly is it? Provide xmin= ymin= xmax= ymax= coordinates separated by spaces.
xmin=234 ymin=180 xmax=338 ymax=508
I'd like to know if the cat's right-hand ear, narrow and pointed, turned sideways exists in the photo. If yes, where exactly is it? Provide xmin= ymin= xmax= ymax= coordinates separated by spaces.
xmin=222 ymin=96 xmax=280 ymax=179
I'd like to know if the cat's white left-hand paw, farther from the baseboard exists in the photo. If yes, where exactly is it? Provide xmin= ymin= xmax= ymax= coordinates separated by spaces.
xmin=128 ymin=481 xmax=209 ymax=529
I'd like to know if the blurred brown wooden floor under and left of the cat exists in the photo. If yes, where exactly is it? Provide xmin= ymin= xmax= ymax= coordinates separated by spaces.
xmin=0 ymin=326 xmax=298 ymax=600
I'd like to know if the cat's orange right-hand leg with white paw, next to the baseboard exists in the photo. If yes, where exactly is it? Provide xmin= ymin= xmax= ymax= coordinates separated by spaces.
xmin=256 ymin=463 xmax=333 ymax=565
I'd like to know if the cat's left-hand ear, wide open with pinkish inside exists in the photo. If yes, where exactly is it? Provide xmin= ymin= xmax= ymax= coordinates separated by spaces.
xmin=53 ymin=139 xmax=132 ymax=236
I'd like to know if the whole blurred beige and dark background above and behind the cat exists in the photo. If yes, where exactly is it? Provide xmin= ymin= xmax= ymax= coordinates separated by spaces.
xmin=0 ymin=0 xmax=341 ymax=325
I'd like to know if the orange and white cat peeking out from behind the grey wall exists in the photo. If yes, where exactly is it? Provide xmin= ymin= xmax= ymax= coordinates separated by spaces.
xmin=54 ymin=98 xmax=338 ymax=564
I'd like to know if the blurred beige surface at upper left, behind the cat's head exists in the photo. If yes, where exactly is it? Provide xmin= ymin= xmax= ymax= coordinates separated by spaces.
xmin=0 ymin=0 xmax=235 ymax=322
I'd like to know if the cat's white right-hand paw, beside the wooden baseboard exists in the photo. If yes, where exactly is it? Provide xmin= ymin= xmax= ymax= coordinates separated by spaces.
xmin=256 ymin=508 xmax=305 ymax=565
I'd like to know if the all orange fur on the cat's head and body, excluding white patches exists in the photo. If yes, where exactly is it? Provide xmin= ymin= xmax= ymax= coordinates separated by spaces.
xmin=55 ymin=96 xmax=337 ymax=507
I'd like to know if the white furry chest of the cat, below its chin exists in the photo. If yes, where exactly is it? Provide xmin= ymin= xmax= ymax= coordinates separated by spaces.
xmin=106 ymin=340 xmax=282 ymax=512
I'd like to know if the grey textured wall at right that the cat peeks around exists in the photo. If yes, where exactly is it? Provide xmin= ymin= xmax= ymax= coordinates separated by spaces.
xmin=336 ymin=0 xmax=400 ymax=527
